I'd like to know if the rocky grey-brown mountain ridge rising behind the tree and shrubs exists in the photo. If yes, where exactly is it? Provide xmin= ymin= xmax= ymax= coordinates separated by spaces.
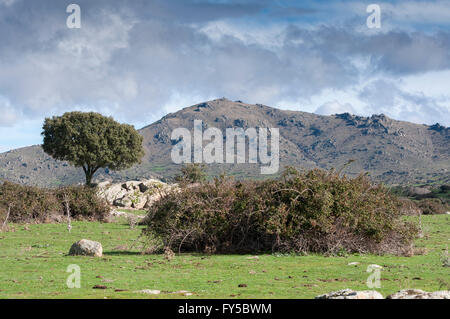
xmin=0 ymin=98 xmax=450 ymax=186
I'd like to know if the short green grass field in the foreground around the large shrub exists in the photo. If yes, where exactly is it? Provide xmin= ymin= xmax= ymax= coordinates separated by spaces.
xmin=0 ymin=215 xmax=450 ymax=298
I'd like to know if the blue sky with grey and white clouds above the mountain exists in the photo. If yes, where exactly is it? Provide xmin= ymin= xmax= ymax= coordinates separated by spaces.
xmin=0 ymin=0 xmax=450 ymax=152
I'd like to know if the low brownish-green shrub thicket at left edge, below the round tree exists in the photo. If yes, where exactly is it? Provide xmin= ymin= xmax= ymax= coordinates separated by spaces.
xmin=0 ymin=182 xmax=109 ymax=223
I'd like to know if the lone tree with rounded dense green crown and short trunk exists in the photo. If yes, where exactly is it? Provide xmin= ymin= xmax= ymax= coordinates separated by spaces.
xmin=42 ymin=112 xmax=144 ymax=186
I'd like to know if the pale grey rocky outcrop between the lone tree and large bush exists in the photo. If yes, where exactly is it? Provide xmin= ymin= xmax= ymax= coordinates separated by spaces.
xmin=98 ymin=179 xmax=175 ymax=209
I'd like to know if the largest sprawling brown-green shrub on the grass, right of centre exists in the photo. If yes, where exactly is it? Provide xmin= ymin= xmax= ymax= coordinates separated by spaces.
xmin=144 ymin=169 xmax=417 ymax=254
